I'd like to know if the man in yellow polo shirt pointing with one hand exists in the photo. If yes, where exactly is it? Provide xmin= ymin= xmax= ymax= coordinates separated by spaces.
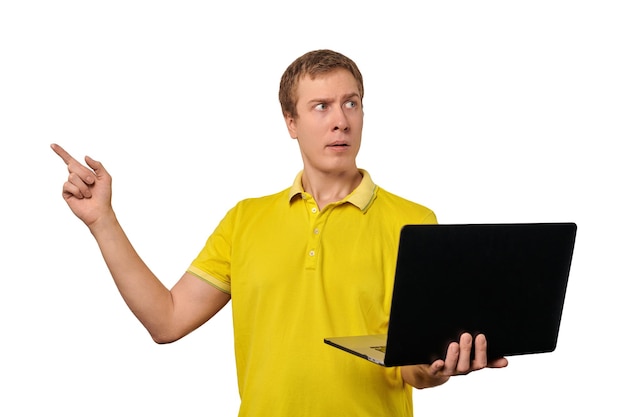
xmin=52 ymin=50 xmax=507 ymax=417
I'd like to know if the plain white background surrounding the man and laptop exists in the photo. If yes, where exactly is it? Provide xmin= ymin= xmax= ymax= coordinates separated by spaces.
xmin=0 ymin=0 xmax=626 ymax=416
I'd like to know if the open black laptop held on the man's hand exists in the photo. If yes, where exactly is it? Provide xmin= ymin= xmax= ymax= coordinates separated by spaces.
xmin=324 ymin=223 xmax=577 ymax=366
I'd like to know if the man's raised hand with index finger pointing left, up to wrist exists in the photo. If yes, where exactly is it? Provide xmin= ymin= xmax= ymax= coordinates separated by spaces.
xmin=50 ymin=143 xmax=113 ymax=227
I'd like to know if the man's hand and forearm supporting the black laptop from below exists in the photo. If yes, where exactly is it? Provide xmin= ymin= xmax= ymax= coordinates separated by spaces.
xmin=401 ymin=333 xmax=508 ymax=389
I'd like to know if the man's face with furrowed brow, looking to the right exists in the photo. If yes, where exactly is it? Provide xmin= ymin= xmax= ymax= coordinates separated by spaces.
xmin=285 ymin=69 xmax=363 ymax=174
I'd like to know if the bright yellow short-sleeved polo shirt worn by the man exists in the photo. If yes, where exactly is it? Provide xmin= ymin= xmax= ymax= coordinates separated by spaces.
xmin=189 ymin=170 xmax=437 ymax=417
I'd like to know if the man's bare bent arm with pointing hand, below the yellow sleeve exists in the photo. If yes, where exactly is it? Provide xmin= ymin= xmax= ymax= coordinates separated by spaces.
xmin=52 ymin=144 xmax=230 ymax=343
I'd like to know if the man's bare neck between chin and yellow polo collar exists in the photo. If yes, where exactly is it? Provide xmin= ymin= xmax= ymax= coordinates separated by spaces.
xmin=302 ymin=168 xmax=363 ymax=210
